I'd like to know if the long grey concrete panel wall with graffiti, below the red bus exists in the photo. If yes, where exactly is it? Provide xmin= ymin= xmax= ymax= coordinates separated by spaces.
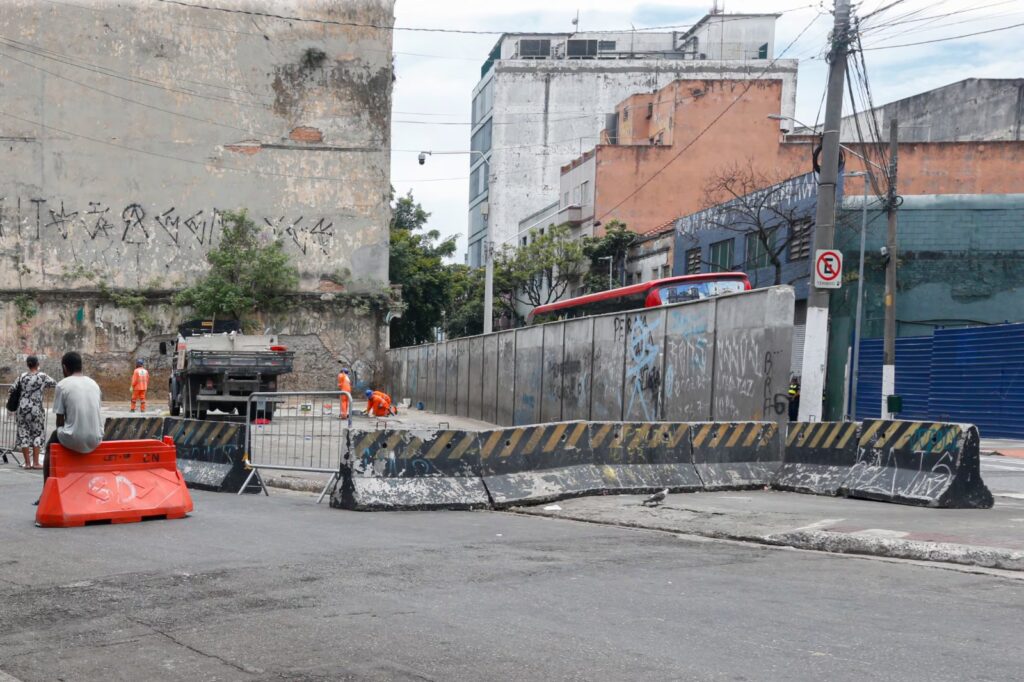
xmin=388 ymin=287 xmax=794 ymax=426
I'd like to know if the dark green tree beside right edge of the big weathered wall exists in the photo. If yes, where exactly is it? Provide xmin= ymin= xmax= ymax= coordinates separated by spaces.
xmin=389 ymin=193 xmax=456 ymax=347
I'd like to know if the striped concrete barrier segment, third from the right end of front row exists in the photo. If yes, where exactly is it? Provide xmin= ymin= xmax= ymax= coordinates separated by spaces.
xmin=690 ymin=422 xmax=782 ymax=489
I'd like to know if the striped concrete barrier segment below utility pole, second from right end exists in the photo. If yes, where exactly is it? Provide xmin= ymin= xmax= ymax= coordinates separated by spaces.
xmin=772 ymin=422 xmax=860 ymax=496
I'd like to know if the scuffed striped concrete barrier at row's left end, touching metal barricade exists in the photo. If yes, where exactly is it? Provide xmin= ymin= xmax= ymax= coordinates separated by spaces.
xmin=331 ymin=429 xmax=489 ymax=511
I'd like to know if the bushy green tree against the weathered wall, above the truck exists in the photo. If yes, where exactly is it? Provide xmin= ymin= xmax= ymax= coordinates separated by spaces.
xmin=174 ymin=210 xmax=299 ymax=322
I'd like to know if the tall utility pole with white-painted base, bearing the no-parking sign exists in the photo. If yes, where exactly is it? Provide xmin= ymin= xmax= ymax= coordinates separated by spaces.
xmin=799 ymin=0 xmax=850 ymax=422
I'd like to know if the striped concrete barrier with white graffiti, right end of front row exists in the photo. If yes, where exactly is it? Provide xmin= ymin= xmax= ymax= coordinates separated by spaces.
xmin=840 ymin=419 xmax=993 ymax=509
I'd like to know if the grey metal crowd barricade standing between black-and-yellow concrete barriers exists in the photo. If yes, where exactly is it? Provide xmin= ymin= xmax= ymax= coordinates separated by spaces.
xmin=239 ymin=391 xmax=354 ymax=504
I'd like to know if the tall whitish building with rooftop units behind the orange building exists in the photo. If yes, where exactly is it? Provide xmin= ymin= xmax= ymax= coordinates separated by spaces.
xmin=468 ymin=14 xmax=797 ymax=266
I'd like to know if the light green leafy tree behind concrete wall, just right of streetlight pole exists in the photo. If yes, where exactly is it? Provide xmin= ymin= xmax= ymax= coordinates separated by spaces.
xmin=495 ymin=225 xmax=587 ymax=307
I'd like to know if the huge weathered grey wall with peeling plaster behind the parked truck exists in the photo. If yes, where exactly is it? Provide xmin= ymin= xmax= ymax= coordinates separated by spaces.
xmin=0 ymin=0 xmax=394 ymax=393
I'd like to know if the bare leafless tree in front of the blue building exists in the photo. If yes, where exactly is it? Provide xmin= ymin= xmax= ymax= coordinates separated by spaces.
xmin=703 ymin=160 xmax=813 ymax=285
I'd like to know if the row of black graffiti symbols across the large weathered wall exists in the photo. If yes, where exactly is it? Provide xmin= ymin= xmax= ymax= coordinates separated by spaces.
xmin=0 ymin=197 xmax=335 ymax=255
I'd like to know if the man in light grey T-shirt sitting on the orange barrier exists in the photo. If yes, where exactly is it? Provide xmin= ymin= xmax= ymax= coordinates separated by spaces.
xmin=35 ymin=351 xmax=103 ymax=505
